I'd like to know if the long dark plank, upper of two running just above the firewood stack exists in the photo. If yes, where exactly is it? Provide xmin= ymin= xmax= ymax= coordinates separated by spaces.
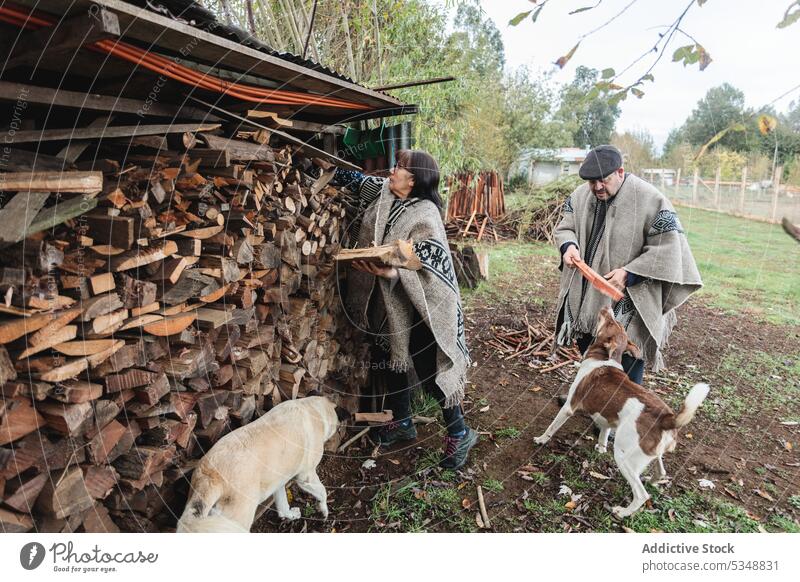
xmin=0 ymin=81 xmax=219 ymax=121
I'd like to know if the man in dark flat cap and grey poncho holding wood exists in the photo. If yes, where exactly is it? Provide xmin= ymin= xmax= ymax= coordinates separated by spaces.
xmin=555 ymin=145 xmax=703 ymax=384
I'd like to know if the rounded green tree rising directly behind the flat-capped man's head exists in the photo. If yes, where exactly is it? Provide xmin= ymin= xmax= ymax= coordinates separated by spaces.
xmin=558 ymin=66 xmax=620 ymax=147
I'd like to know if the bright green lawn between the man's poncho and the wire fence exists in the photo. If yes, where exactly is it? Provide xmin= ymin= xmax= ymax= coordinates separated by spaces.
xmin=678 ymin=208 xmax=800 ymax=325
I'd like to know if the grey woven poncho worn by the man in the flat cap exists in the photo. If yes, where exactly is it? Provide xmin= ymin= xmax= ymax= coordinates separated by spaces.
xmin=554 ymin=174 xmax=703 ymax=372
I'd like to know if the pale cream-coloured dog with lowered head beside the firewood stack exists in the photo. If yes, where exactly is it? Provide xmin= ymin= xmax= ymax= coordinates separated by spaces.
xmin=177 ymin=396 xmax=346 ymax=533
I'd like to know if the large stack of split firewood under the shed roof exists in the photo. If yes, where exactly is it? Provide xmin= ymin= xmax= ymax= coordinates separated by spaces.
xmin=0 ymin=131 xmax=365 ymax=532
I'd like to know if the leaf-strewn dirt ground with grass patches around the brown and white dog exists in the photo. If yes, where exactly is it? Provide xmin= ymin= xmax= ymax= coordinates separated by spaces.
xmin=253 ymin=250 xmax=800 ymax=532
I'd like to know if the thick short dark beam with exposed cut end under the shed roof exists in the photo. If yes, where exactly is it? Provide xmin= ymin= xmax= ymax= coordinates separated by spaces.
xmin=6 ymin=8 xmax=119 ymax=69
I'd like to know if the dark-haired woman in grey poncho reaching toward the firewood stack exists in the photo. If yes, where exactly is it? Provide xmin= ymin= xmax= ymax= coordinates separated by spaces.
xmin=315 ymin=150 xmax=478 ymax=469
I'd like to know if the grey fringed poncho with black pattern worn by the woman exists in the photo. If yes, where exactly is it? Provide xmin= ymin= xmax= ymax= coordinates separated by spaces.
xmin=347 ymin=180 xmax=470 ymax=408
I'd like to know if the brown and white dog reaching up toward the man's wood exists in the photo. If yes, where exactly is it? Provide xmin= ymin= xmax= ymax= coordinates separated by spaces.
xmin=534 ymin=307 xmax=709 ymax=518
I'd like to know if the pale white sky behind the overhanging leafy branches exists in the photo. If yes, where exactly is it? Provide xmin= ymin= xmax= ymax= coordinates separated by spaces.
xmin=472 ymin=0 xmax=800 ymax=148
